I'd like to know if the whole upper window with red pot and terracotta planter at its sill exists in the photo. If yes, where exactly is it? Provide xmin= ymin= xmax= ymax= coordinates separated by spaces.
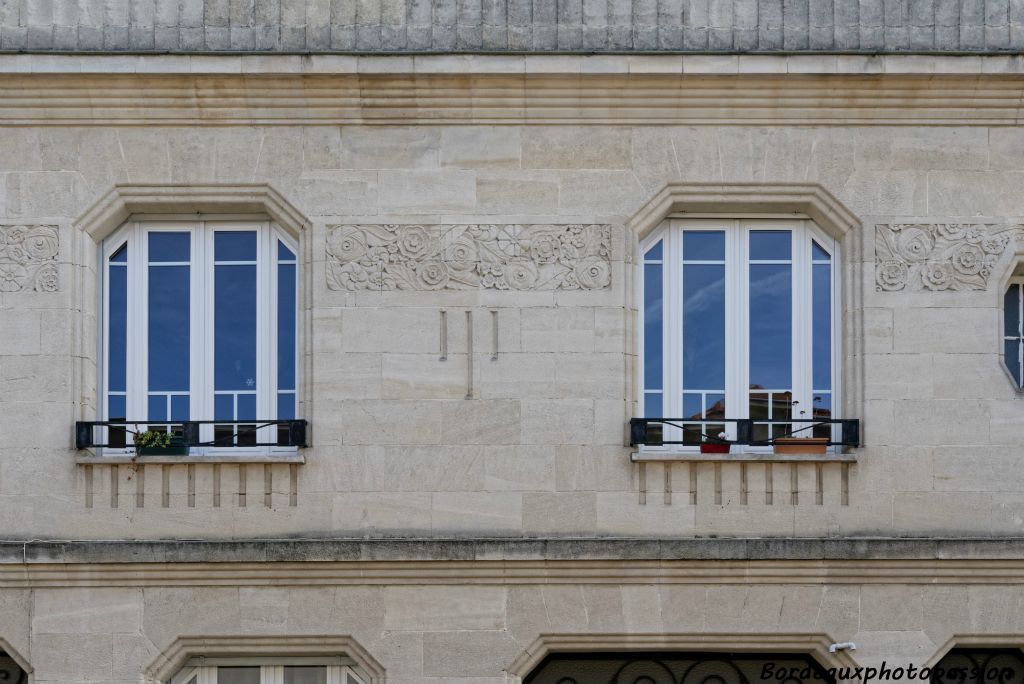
xmin=640 ymin=219 xmax=841 ymax=450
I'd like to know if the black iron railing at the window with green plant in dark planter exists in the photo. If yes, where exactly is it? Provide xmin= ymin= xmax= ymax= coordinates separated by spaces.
xmin=75 ymin=420 xmax=306 ymax=448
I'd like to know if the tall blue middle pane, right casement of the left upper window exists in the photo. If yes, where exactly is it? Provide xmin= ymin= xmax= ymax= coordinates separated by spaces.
xmin=213 ymin=266 xmax=256 ymax=390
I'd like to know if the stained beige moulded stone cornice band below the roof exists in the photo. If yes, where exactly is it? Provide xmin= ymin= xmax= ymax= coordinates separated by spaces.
xmin=6 ymin=73 xmax=1024 ymax=126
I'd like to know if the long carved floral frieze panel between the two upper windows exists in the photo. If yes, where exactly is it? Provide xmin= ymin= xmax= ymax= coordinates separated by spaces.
xmin=327 ymin=223 xmax=611 ymax=290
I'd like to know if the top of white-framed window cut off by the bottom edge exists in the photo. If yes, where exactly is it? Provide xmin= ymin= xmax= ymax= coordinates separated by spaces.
xmin=171 ymin=658 xmax=365 ymax=684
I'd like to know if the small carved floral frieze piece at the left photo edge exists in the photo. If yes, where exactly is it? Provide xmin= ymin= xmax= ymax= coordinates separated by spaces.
xmin=0 ymin=225 xmax=60 ymax=292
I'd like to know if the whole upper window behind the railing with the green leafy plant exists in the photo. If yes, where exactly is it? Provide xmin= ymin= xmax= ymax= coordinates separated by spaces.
xmin=100 ymin=221 xmax=298 ymax=454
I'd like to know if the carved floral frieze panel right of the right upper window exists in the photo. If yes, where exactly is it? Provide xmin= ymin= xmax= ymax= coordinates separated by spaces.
xmin=874 ymin=223 xmax=1024 ymax=292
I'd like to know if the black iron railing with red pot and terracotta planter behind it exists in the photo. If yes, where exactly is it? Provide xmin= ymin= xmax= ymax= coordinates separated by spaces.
xmin=630 ymin=418 xmax=860 ymax=446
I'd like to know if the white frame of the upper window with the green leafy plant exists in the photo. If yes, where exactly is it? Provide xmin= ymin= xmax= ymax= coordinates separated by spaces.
xmin=97 ymin=216 xmax=302 ymax=459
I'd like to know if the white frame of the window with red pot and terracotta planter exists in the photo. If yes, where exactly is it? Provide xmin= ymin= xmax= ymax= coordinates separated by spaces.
xmin=636 ymin=216 xmax=843 ymax=454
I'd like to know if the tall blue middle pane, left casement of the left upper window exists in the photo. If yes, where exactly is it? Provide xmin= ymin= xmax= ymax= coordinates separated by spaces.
xmin=148 ymin=266 xmax=189 ymax=391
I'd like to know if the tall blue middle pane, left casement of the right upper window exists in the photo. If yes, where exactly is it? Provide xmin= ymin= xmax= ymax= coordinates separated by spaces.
xmin=683 ymin=264 xmax=725 ymax=390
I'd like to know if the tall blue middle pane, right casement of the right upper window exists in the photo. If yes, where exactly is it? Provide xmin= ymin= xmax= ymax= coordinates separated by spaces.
xmin=750 ymin=264 xmax=793 ymax=389
